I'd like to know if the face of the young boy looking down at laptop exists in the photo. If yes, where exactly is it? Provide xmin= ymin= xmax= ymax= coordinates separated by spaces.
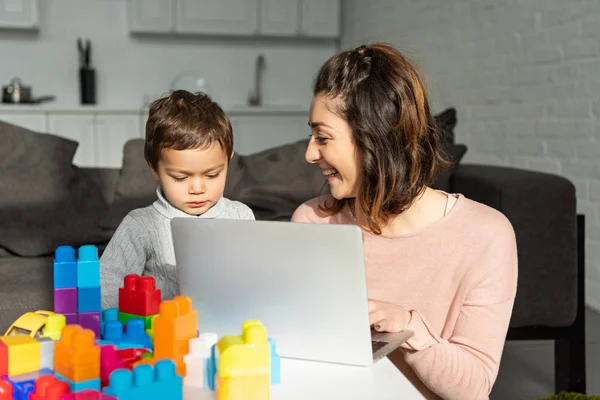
xmin=152 ymin=142 xmax=228 ymax=215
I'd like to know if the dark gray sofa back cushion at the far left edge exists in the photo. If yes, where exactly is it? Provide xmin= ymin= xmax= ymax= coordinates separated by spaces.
xmin=0 ymin=122 xmax=110 ymax=257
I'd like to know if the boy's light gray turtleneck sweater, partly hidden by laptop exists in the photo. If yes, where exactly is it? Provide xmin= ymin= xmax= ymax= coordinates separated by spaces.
xmin=100 ymin=187 xmax=255 ymax=309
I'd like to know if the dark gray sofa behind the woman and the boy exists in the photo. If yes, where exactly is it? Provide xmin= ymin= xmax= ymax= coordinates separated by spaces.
xmin=0 ymin=113 xmax=585 ymax=392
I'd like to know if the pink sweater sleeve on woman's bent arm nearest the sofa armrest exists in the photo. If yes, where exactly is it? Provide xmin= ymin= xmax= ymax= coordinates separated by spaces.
xmin=402 ymin=221 xmax=518 ymax=400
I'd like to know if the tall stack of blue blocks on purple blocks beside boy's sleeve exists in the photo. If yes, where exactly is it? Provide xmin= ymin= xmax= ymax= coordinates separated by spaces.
xmin=54 ymin=245 xmax=102 ymax=338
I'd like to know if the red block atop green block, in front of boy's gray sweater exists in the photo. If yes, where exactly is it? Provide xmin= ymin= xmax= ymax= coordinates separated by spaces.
xmin=119 ymin=274 xmax=160 ymax=317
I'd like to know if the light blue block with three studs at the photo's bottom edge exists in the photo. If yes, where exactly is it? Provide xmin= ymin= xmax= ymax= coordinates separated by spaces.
xmin=103 ymin=359 xmax=183 ymax=400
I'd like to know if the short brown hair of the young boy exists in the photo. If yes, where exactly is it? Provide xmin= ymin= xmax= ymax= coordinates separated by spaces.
xmin=144 ymin=90 xmax=233 ymax=171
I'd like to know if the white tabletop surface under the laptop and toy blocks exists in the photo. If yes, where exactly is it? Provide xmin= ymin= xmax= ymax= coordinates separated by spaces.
xmin=184 ymin=358 xmax=424 ymax=400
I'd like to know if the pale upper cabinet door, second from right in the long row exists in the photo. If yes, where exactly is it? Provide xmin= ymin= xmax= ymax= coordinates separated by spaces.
xmin=259 ymin=0 xmax=300 ymax=36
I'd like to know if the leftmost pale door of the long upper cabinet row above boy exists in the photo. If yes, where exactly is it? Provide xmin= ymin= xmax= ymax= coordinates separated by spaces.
xmin=127 ymin=0 xmax=175 ymax=33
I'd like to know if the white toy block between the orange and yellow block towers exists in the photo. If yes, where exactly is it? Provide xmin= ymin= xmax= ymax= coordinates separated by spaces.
xmin=183 ymin=333 xmax=218 ymax=387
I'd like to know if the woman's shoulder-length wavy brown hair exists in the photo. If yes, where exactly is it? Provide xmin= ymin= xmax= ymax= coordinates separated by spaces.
xmin=313 ymin=43 xmax=450 ymax=234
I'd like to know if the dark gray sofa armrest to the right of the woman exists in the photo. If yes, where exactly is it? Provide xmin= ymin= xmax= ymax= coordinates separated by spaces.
xmin=451 ymin=164 xmax=577 ymax=328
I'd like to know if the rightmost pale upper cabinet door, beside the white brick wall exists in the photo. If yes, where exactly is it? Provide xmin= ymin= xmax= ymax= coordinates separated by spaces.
xmin=300 ymin=0 xmax=341 ymax=38
